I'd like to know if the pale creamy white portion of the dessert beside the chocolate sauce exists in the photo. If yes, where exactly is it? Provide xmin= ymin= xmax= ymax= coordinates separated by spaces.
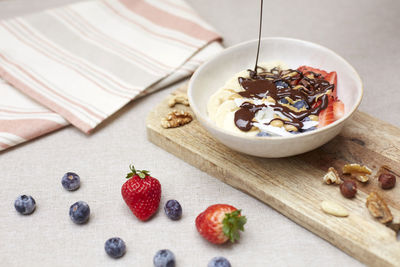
xmin=207 ymin=61 xmax=318 ymax=136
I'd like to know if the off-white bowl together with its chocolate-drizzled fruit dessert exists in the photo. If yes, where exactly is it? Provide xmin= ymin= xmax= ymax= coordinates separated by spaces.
xmin=188 ymin=37 xmax=363 ymax=158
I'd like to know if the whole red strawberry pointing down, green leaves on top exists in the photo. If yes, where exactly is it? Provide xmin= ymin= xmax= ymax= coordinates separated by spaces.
xmin=121 ymin=165 xmax=161 ymax=221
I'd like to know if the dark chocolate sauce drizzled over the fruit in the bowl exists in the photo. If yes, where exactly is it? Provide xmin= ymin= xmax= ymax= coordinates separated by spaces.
xmin=235 ymin=67 xmax=335 ymax=131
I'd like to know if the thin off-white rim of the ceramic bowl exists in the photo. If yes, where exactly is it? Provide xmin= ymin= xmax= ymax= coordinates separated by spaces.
xmin=188 ymin=37 xmax=364 ymax=140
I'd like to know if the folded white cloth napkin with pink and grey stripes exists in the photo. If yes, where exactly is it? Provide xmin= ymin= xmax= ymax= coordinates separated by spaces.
xmin=0 ymin=0 xmax=222 ymax=150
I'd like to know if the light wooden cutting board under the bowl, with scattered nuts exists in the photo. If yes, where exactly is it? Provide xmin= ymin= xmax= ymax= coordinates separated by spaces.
xmin=147 ymin=83 xmax=400 ymax=266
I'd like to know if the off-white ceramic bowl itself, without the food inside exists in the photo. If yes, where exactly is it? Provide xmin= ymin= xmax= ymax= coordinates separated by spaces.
xmin=188 ymin=37 xmax=363 ymax=158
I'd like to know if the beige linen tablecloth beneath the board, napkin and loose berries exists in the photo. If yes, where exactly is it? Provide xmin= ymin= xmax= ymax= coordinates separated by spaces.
xmin=0 ymin=0 xmax=400 ymax=267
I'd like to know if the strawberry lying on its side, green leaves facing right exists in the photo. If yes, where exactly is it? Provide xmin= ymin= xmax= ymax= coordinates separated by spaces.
xmin=196 ymin=204 xmax=247 ymax=244
